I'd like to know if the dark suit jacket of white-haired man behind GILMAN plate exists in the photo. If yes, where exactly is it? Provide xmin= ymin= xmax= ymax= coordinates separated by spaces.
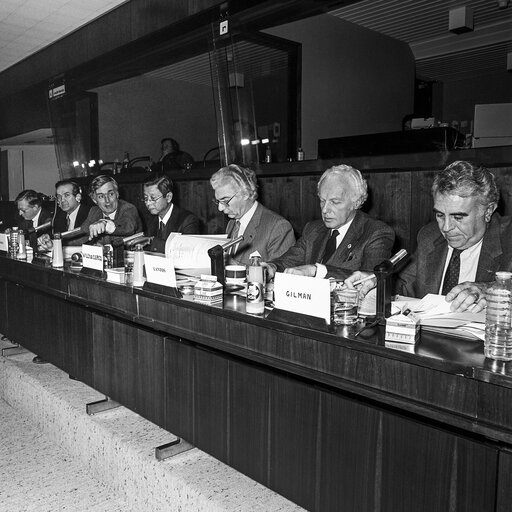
xmin=271 ymin=210 xmax=395 ymax=279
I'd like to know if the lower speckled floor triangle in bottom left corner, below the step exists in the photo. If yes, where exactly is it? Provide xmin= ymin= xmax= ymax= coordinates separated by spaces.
xmin=0 ymin=400 xmax=130 ymax=512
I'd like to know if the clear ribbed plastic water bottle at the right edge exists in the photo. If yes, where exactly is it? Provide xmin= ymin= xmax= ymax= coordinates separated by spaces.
xmin=484 ymin=272 xmax=512 ymax=361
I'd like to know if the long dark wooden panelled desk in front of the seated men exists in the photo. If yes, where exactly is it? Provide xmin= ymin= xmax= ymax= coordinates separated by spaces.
xmin=0 ymin=256 xmax=512 ymax=512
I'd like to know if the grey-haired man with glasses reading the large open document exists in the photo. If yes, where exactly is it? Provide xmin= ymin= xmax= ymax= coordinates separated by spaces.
xmin=210 ymin=164 xmax=295 ymax=265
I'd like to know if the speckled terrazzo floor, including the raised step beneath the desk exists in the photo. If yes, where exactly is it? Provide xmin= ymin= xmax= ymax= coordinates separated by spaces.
xmin=0 ymin=340 xmax=303 ymax=512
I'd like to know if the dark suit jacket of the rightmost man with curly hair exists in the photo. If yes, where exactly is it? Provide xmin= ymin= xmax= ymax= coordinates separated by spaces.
xmin=396 ymin=213 xmax=512 ymax=298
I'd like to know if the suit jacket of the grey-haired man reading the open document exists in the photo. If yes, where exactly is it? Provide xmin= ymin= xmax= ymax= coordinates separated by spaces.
xmin=226 ymin=203 xmax=295 ymax=266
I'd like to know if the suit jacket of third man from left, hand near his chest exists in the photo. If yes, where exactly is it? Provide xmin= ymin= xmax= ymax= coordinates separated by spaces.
xmin=69 ymin=199 xmax=142 ymax=246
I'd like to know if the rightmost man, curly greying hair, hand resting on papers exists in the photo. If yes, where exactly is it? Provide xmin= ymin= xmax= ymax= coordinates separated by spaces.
xmin=346 ymin=161 xmax=512 ymax=312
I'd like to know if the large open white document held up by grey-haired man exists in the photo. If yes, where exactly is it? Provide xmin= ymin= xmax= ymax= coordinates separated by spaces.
xmin=165 ymin=233 xmax=227 ymax=270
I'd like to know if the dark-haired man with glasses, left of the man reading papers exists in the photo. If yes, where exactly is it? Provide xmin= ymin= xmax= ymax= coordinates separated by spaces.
xmin=143 ymin=174 xmax=199 ymax=252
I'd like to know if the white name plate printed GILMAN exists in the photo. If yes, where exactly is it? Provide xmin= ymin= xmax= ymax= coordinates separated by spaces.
xmin=274 ymin=272 xmax=331 ymax=324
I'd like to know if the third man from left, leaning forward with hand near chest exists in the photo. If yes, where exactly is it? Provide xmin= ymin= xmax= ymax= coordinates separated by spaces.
xmin=70 ymin=175 xmax=142 ymax=246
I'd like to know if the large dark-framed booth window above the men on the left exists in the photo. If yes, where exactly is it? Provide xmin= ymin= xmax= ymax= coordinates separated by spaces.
xmin=48 ymin=25 xmax=300 ymax=178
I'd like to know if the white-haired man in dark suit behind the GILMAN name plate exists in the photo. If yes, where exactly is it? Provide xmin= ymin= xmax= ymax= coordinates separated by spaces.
xmin=268 ymin=165 xmax=395 ymax=279
